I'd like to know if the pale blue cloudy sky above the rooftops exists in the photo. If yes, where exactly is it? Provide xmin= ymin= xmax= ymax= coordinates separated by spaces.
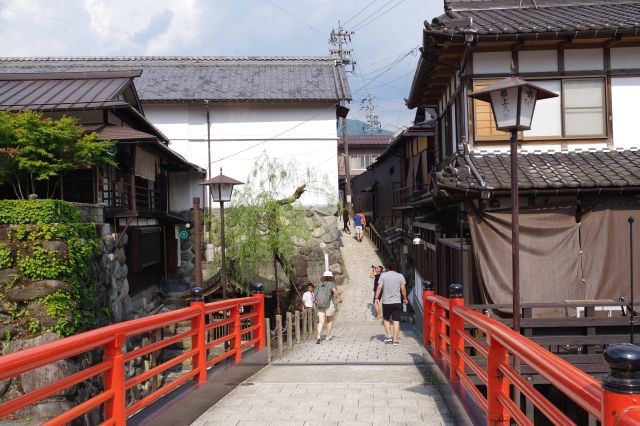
xmin=0 ymin=0 xmax=443 ymax=131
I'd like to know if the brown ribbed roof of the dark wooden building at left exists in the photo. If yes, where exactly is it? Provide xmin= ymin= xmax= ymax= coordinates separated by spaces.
xmin=0 ymin=72 xmax=139 ymax=111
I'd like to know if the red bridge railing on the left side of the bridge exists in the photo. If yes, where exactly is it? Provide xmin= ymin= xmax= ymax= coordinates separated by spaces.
xmin=0 ymin=288 xmax=265 ymax=426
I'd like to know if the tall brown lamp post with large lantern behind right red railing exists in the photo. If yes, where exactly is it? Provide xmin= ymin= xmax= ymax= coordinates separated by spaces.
xmin=469 ymin=75 xmax=558 ymax=333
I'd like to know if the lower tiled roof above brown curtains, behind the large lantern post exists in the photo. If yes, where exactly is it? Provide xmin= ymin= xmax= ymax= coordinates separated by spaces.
xmin=438 ymin=149 xmax=640 ymax=190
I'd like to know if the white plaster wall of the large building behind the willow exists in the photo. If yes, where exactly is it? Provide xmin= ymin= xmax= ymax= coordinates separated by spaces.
xmin=144 ymin=103 xmax=338 ymax=204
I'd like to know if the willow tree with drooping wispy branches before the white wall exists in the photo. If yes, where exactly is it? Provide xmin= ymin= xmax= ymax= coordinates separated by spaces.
xmin=211 ymin=154 xmax=335 ymax=311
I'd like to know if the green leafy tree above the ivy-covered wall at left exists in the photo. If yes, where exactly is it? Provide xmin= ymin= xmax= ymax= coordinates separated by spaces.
xmin=0 ymin=110 xmax=115 ymax=198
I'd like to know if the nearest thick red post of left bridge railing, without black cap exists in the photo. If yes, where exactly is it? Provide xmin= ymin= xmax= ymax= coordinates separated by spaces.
xmin=104 ymin=334 xmax=127 ymax=426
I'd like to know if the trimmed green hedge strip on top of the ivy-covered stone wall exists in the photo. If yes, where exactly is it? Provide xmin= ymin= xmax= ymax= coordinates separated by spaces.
xmin=0 ymin=200 xmax=81 ymax=224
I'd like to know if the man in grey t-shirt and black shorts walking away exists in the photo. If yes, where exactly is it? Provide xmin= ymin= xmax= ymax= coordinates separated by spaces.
xmin=375 ymin=265 xmax=408 ymax=345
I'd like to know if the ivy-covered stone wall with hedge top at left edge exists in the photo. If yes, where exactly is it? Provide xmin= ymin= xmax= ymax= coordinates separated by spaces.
xmin=0 ymin=200 xmax=99 ymax=336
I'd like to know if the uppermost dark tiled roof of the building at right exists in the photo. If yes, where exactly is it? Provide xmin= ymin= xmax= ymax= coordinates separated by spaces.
xmin=427 ymin=0 xmax=640 ymax=35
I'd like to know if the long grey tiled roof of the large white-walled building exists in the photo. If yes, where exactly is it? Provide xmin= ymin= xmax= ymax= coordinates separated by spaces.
xmin=0 ymin=57 xmax=351 ymax=102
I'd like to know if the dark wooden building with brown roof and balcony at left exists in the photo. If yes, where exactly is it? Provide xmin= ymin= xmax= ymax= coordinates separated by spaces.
xmin=0 ymin=70 xmax=204 ymax=294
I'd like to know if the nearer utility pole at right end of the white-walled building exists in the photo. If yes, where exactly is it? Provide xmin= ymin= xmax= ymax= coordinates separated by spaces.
xmin=329 ymin=21 xmax=356 ymax=217
